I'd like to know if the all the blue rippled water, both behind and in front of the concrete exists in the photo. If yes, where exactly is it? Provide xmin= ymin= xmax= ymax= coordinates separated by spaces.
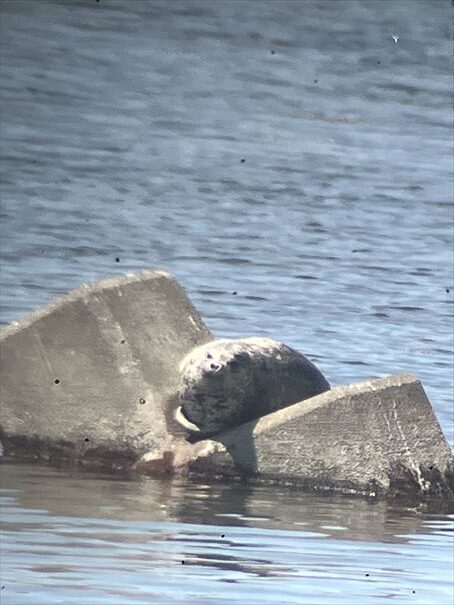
xmin=0 ymin=0 xmax=454 ymax=605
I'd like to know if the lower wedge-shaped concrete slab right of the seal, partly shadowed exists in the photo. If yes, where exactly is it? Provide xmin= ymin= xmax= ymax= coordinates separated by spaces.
xmin=148 ymin=375 xmax=454 ymax=501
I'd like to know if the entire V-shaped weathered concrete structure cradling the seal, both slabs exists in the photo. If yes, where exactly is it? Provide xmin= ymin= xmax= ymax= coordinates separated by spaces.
xmin=0 ymin=271 xmax=454 ymax=504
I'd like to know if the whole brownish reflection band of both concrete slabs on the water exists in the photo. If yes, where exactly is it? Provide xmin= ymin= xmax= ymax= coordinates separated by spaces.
xmin=1 ymin=464 xmax=440 ymax=543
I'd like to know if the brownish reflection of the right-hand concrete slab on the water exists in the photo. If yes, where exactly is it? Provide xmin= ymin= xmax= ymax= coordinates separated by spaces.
xmin=173 ymin=484 xmax=427 ymax=543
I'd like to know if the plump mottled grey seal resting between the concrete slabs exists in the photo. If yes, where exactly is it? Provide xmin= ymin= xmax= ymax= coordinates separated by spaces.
xmin=175 ymin=337 xmax=330 ymax=441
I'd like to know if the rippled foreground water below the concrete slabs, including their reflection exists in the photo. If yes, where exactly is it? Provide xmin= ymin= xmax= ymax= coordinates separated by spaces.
xmin=1 ymin=464 xmax=454 ymax=605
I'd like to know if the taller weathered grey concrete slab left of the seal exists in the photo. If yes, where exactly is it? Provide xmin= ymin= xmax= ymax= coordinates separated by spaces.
xmin=0 ymin=271 xmax=212 ymax=466
